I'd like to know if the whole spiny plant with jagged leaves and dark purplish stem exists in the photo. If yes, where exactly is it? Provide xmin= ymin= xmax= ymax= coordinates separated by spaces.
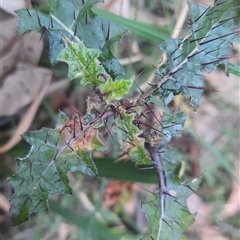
xmin=9 ymin=0 xmax=237 ymax=239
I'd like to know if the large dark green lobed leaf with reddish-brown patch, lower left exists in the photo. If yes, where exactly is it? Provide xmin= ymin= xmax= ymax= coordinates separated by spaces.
xmin=9 ymin=112 xmax=105 ymax=226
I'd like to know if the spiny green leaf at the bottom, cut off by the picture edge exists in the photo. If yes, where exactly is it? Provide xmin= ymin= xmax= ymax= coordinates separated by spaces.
xmin=142 ymin=172 xmax=200 ymax=240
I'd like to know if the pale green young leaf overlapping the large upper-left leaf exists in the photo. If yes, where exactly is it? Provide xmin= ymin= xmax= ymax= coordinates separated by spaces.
xmin=57 ymin=39 xmax=106 ymax=86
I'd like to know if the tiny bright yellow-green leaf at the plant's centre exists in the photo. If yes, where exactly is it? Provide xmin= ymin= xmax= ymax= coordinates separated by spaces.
xmin=100 ymin=78 xmax=133 ymax=104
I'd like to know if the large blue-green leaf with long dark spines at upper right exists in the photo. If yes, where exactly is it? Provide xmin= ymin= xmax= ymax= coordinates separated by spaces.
xmin=156 ymin=0 xmax=236 ymax=109
